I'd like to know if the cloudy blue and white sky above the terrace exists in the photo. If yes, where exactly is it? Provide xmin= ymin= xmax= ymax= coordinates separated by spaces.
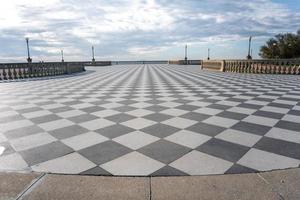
xmin=0 ymin=0 xmax=300 ymax=62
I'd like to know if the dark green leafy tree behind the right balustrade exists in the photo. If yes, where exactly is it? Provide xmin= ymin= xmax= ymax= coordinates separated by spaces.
xmin=259 ymin=29 xmax=300 ymax=59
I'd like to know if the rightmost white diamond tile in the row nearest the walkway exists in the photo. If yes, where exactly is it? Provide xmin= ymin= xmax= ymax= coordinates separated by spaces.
xmin=237 ymin=149 xmax=300 ymax=171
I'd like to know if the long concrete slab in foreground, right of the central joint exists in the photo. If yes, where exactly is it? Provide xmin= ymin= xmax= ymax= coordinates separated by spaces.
xmin=151 ymin=174 xmax=280 ymax=200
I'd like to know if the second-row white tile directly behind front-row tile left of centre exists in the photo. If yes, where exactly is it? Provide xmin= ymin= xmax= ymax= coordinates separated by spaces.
xmin=61 ymin=132 xmax=108 ymax=151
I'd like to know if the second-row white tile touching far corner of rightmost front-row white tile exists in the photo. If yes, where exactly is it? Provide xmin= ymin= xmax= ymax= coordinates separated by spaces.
xmin=215 ymin=129 xmax=262 ymax=147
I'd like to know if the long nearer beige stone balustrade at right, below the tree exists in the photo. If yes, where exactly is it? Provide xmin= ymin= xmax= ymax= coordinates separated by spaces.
xmin=202 ymin=59 xmax=300 ymax=74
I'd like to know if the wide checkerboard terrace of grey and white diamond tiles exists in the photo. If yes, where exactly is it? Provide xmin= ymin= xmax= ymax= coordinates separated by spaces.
xmin=0 ymin=65 xmax=300 ymax=176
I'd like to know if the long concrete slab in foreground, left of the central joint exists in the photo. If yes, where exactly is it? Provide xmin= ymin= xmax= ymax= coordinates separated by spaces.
xmin=23 ymin=175 xmax=150 ymax=200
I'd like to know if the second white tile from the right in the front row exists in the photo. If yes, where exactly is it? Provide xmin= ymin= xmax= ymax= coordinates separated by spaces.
xmin=170 ymin=150 xmax=233 ymax=175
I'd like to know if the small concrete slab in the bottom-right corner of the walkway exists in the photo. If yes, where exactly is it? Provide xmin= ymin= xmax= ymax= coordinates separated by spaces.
xmin=260 ymin=168 xmax=300 ymax=200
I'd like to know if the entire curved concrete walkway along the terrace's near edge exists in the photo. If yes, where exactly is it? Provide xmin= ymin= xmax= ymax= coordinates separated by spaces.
xmin=0 ymin=168 xmax=300 ymax=200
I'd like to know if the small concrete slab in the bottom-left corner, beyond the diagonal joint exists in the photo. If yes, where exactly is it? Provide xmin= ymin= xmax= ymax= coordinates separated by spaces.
xmin=0 ymin=173 xmax=40 ymax=200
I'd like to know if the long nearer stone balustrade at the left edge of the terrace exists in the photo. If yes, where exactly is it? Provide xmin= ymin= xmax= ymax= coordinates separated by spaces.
xmin=0 ymin=62 xmax=85 ymax=80
